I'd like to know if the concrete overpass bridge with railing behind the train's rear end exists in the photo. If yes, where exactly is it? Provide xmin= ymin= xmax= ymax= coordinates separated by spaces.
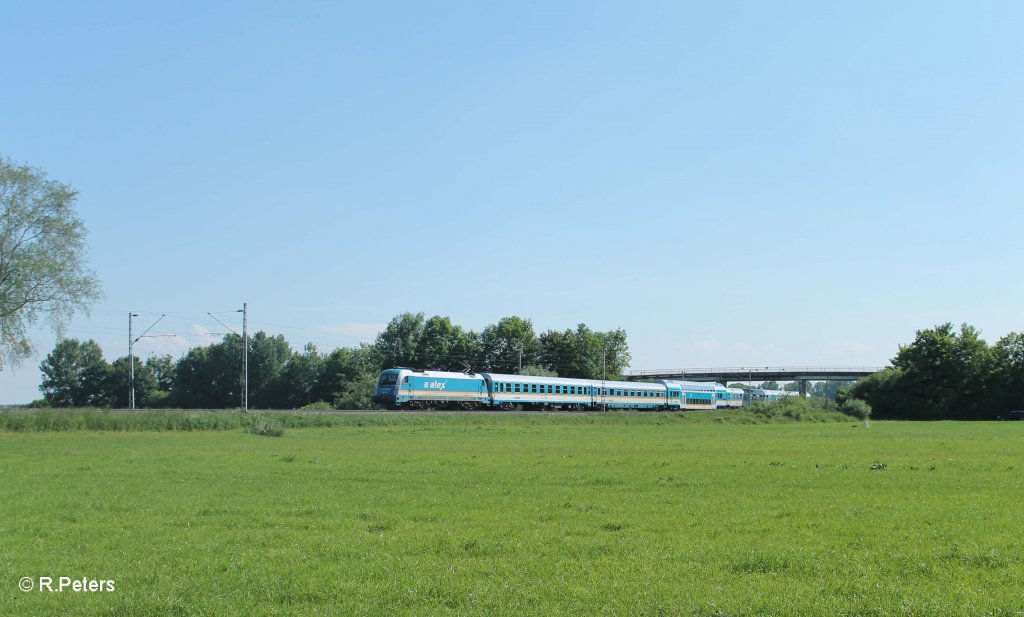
xmin=626 ymin=366 xmax=885 ymax=394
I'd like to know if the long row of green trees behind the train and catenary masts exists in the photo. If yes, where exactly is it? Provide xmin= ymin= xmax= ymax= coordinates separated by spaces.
xmin=36 ymin=313 xmax=630 ymax=409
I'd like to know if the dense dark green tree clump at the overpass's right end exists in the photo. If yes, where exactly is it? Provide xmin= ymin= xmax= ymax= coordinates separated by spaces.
xmin=838 ymin=322 xmax=1024 ymax=420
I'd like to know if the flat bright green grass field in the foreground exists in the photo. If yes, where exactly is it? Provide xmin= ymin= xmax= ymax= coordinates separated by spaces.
xmin=0 ymin=414 xmax=1024 ymax=616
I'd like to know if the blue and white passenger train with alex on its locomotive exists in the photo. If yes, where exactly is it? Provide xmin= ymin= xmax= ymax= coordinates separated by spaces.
xmin=372 ymin=366 xmax=770 ymax=411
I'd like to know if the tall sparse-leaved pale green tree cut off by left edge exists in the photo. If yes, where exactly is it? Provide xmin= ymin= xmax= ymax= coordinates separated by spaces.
xmin=0 ymin=158 xmax=100 ymax=369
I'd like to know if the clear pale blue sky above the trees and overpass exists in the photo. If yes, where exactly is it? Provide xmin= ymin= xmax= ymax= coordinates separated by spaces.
xmin=0 ymin=0 xmax=1024 ymax=403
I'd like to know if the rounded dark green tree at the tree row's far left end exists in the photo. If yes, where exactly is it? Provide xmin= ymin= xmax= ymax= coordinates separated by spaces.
xmin=39 ymin=339 xmax=111 ymax=407
